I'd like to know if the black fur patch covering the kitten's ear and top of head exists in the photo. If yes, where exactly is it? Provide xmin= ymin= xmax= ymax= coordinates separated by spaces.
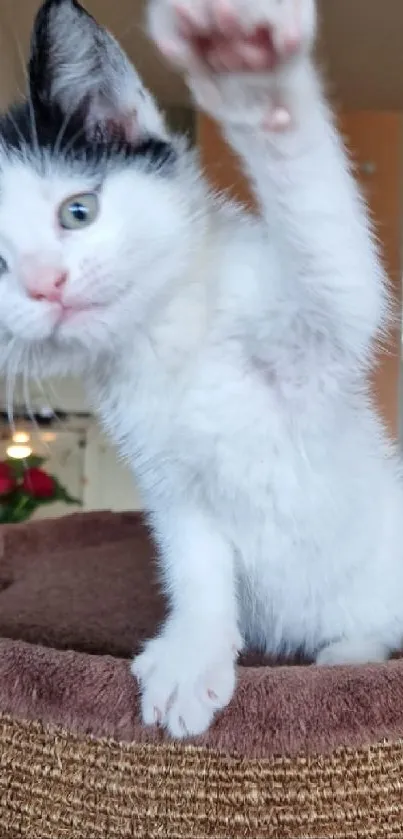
xmin=0 ymin=0 xmax=177 ymax=174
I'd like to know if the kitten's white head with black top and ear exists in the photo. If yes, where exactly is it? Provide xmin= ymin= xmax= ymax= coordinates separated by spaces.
xmin=0 ymin=0 xmax=199 ymax=374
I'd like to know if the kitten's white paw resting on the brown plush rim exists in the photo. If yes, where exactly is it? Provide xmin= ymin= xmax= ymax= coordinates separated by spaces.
xmin=132 ymin=628 xmax=239 ymax=738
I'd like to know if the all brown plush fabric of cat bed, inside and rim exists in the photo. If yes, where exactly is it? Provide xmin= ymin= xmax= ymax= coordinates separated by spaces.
xmin=0 ymin=513 xmax=403 ymax=760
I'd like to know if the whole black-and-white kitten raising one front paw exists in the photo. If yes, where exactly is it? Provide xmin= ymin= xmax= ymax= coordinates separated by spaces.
xmin=0 ymin=0 xmax=403 ymax=737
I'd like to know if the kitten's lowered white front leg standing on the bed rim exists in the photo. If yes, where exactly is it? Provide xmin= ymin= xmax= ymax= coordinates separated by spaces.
xmin=132 ymin=509 xmax=241 ymax=737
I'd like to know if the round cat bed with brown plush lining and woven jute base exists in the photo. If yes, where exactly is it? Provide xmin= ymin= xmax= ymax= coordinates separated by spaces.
xmin=0 ymin=513 xmax=403 ymax=839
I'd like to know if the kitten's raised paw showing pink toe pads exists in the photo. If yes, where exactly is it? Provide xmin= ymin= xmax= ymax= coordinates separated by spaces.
xmin=149 ymin=0 xmax=316 ymax=75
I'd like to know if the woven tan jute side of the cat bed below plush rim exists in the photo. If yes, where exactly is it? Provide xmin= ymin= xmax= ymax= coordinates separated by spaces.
xmin=0 ymin=716 xmax=403 ymax=839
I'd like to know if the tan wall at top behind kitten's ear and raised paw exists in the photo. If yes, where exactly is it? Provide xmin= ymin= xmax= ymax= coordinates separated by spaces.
xmin=0 ymin=0 xmax=403 ymax=110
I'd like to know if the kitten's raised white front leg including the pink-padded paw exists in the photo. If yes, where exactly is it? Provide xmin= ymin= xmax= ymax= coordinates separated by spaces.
xmin=149 ymin=0 xmax=389 ymax=370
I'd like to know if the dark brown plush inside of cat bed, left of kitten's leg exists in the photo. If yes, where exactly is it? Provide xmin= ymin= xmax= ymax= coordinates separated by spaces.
xmin=0 ymin=513 xmax=164 ymax=658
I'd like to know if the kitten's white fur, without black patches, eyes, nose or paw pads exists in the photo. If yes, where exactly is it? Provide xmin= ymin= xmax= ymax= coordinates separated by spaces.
xmin=0 ymin=0 xmax=403 ymax=736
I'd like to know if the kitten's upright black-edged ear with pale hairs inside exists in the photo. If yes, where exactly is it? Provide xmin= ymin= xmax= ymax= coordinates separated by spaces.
xmin=29 ymin=0 xmax=167 ymax=142
